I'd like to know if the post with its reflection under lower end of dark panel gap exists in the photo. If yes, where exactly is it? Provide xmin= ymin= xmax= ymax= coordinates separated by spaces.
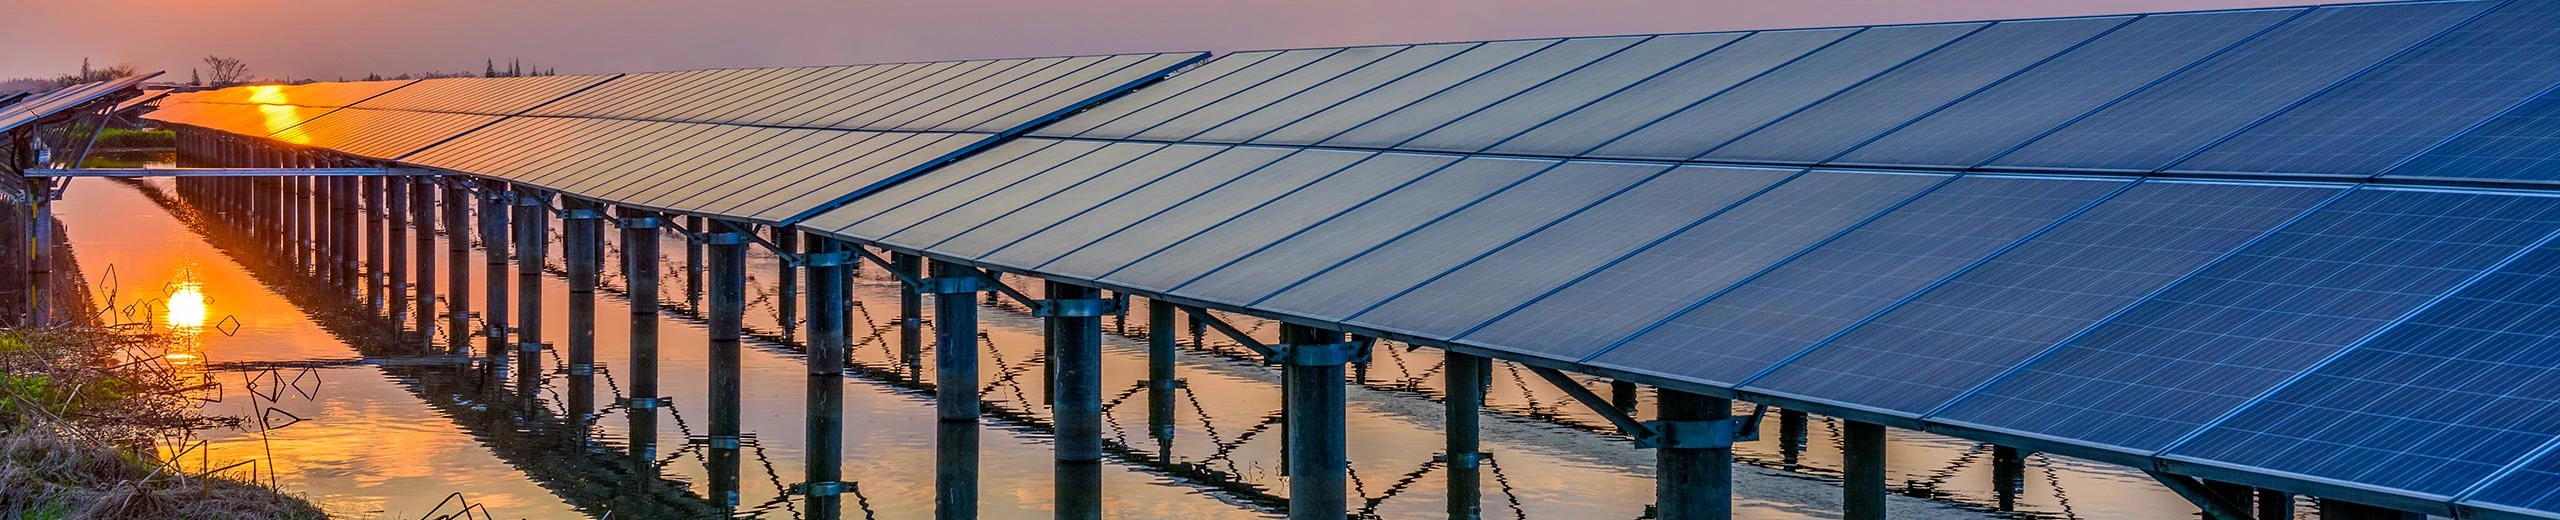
xmin=808 ymin=231 xmax=852 ymax=520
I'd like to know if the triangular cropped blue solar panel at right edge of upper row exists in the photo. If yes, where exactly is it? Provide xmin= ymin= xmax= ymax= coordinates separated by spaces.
xmin=2388 ymin=85 xmax=2560 ymax=182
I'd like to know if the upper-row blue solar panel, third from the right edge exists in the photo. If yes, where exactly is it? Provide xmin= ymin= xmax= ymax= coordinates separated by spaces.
xmin=1992 ymin=3 xmax=2496 ymax=172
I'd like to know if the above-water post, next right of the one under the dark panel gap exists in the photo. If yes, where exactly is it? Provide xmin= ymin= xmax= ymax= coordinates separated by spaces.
xmin=932 ymin=261 xmax=978 ymax=420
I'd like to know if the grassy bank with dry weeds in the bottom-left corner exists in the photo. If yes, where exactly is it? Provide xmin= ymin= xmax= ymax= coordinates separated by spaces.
xmin=0 ymin=328 xmax=325 ymax=520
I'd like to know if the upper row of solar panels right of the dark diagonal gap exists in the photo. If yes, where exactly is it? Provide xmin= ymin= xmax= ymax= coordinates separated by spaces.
xmin=1037 ymin=3 xmax=2560 ymax=182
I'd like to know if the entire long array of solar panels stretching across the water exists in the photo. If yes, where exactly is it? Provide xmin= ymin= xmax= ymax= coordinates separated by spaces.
xmin=154 ymin=3 xmax=2560 ymax=517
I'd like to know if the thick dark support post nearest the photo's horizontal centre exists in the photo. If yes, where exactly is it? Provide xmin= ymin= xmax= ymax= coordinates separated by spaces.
xmin=1280 ymin=323 xmax=1349 ymax=520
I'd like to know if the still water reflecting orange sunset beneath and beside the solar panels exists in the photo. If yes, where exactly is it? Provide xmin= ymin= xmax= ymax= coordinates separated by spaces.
xmin=56 ymin=169 xmax=2232 ymax=517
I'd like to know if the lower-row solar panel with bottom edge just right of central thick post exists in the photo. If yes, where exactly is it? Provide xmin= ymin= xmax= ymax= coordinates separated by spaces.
xmin=1349 ymin=167 xmax=1797 ymax=338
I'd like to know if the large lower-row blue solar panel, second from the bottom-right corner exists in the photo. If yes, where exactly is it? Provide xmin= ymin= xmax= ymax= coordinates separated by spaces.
xmin=2171 ymin=236 xmax=2560 ymax=497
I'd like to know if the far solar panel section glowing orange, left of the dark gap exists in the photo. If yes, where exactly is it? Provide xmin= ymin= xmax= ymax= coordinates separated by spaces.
xmin=146 ymin=54 xmax=1206 ymax=223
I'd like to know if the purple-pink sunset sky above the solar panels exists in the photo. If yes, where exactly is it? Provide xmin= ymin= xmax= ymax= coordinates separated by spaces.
xmin=0 ymin=0 xmax=2355 ymax=79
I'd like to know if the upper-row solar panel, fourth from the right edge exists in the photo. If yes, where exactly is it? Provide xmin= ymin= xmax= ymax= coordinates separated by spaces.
xmin=1833 ymin=8 xmax=2304 ymax=167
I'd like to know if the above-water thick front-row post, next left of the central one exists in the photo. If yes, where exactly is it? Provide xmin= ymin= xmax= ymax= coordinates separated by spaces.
xmin=1044 ymin=282 xmax=1106 ymax=463
